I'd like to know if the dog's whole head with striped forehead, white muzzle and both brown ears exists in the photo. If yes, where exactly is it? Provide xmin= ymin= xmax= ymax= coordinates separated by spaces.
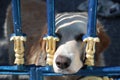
xmin=26 ymin=13 xmax=110 ymax=74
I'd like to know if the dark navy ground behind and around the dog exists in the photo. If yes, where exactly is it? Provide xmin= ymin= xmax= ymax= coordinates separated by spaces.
xmin=0 ymin=0 xmax=120 ymax=66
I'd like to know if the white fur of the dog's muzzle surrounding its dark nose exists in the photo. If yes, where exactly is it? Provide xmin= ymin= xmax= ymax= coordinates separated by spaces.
xmin=53 ymin=41 xmax=83 ymax=74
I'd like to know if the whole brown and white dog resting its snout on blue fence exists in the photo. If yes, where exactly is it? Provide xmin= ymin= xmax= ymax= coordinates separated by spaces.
xmin=6 ymin=0 xmax=110 ymax=80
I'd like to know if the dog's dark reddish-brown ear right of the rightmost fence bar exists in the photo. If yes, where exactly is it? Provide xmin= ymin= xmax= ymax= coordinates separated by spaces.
xmin=95 ymin=21 xmax=110 ymax=65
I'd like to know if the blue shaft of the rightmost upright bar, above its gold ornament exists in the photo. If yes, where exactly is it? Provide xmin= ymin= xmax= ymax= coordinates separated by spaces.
xmin=87 ymin=0 xmax=98 ymax=37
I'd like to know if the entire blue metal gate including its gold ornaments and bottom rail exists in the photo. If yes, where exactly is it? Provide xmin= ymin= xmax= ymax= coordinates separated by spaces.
xmin=0 ymin=0 xmax=120 ymax=80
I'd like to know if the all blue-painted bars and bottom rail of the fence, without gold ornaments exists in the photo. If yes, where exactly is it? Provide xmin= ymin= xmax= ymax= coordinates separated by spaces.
xmin=0 ymin=0 xmax=120 ymax=80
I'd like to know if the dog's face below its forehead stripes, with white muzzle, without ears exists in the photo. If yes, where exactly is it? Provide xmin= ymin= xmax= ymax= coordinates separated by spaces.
xmin=53 ymin=23 xmax=86 ymax=74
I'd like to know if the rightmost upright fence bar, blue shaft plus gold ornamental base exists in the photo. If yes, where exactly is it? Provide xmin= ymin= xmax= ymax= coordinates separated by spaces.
xmin=83 ymin=0 xmax=100 ymax=66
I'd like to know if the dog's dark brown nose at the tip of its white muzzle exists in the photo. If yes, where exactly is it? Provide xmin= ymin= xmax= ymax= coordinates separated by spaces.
xmin=56 ymin=55 xmax=71 ymax=69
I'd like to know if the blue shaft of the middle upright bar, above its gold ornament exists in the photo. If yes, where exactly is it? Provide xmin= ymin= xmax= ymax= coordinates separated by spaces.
xmin=47 ymin=0 xmax=55 ymax=36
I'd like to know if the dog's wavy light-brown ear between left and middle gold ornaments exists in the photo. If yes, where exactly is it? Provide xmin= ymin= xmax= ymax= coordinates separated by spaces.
xmin=26 ymin=27 xmax=47 ymax=66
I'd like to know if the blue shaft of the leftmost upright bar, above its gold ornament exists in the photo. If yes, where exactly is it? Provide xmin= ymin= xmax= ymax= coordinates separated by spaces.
xmin=12 ymin=0 xmax=22 ymax=36
